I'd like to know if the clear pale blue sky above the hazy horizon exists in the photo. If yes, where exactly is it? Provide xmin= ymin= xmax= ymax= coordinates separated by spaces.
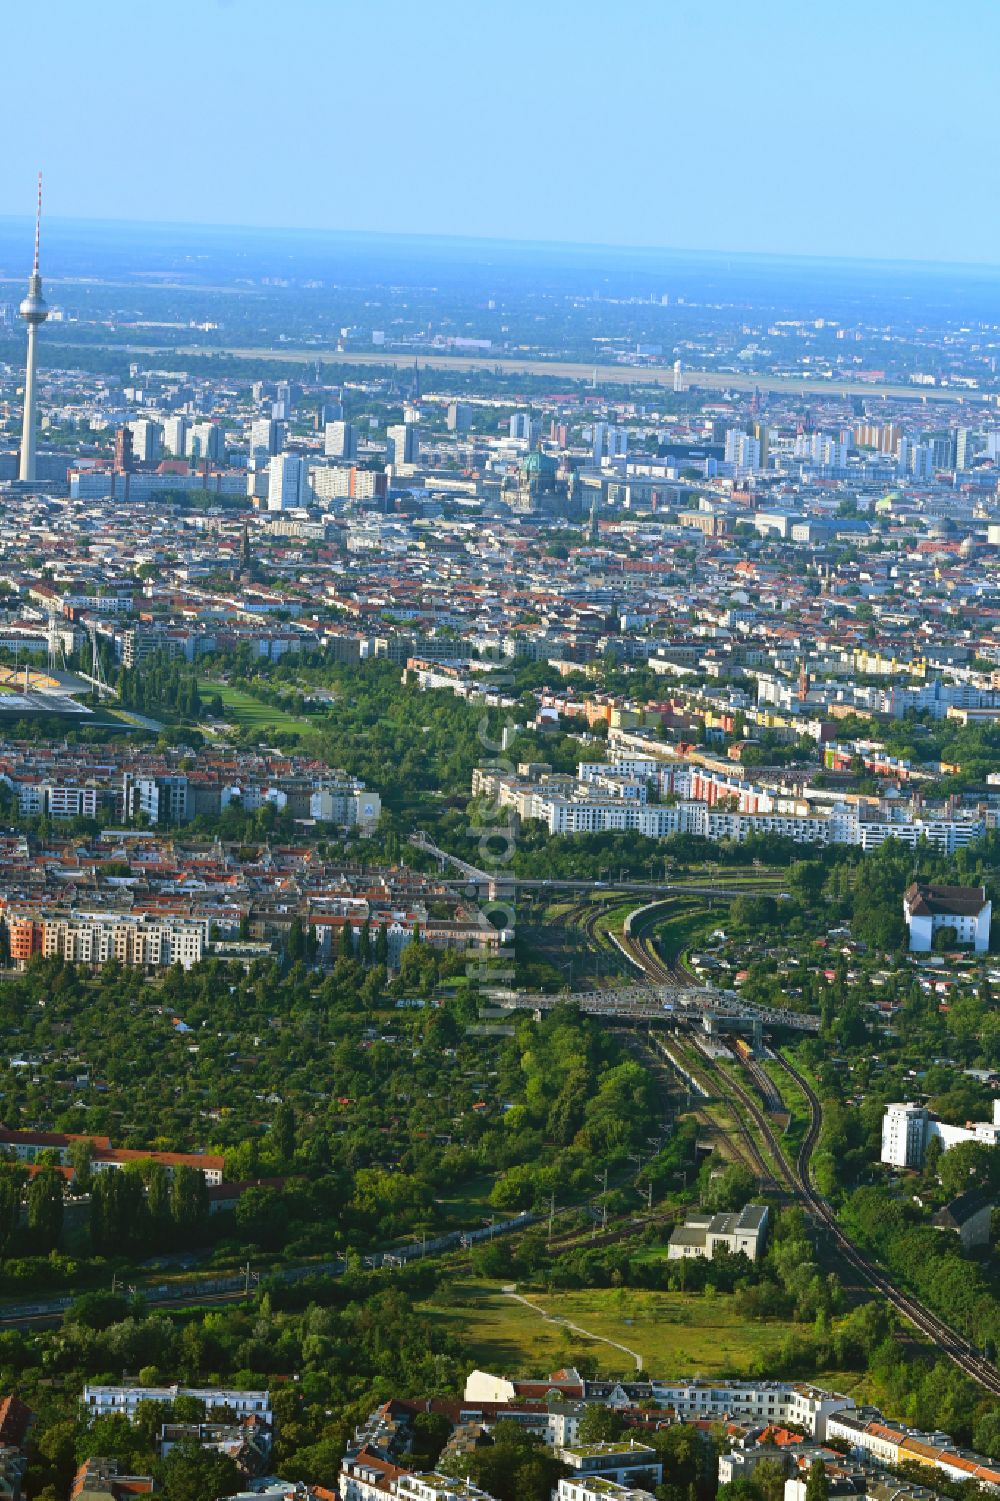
xmin=7 ymin=0 xmax=1000 ymax=263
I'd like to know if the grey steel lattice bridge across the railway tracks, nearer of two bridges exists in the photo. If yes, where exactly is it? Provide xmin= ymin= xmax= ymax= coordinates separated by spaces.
xmin=488 ymin=985 xmax=820 ymax=1036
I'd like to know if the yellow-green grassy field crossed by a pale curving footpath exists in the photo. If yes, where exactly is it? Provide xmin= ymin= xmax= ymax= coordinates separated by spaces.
xmin=411 ymin=1279 xmax=840 ymax=1378
